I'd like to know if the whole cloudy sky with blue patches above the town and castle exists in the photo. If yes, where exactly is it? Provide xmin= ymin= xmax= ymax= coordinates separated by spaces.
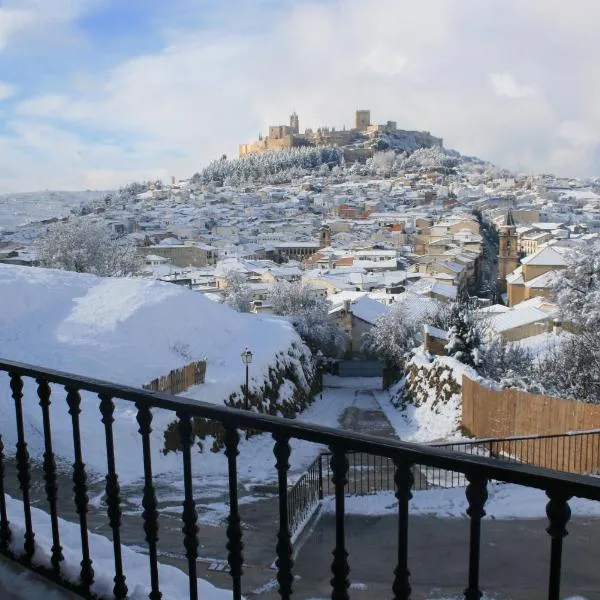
xmin=0 ymin=0 xmax=600 ymax=193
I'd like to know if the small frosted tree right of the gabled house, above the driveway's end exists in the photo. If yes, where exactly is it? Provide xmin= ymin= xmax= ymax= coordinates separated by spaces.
xmin=363 ymin=302 xmax=422 ymax=369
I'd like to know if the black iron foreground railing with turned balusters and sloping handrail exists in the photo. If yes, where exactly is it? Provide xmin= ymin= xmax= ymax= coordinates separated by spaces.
xmin=0 ymin=360 xmax=600 ymax=600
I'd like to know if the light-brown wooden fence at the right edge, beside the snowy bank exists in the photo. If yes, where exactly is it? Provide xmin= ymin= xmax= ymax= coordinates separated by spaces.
xmin=462 ymin=376 xmax=600 ymax=473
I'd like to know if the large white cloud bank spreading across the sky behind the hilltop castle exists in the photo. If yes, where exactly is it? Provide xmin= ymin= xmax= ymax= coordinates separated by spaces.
xmin=5 ymin=0 xmax=600 ymax=189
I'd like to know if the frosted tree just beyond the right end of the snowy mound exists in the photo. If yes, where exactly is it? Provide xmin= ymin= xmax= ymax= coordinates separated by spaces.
xmin=268 ymin=281 xmax=346 ymax=356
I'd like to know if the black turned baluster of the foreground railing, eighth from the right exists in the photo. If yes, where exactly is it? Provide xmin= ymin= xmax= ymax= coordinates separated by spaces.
xmin=136 ymin=404 xmax=162 ymax=600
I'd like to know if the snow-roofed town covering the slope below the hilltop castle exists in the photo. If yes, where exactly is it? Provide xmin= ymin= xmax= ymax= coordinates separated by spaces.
xmin=0 ymin=111 xmax=600 ymax=366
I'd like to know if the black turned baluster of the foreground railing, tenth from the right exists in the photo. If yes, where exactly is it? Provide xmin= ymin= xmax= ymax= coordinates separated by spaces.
xmin=65 ymin=386 xmax=94 ymax=593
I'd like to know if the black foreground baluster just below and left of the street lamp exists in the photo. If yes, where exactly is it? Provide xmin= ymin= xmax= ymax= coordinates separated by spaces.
xmin=225 ymin=425 xmax=244 ymax=600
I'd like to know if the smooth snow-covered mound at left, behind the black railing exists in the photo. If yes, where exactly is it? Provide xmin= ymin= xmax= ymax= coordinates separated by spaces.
xmin=0 ymin=265 xmax=306 ymax=479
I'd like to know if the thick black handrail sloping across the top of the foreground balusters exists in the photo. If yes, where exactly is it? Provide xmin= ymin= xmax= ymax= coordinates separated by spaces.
xmin=0 ymin=359 xmax=600 ymax=500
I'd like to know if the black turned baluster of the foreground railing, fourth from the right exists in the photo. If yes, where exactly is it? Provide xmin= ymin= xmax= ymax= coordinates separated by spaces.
xmin=331 ymin=446 xmax=350 ymax=600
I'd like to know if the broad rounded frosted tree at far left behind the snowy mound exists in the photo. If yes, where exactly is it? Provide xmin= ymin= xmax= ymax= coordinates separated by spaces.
xmin=35 ymin=218 xmax=141 ymax=277
